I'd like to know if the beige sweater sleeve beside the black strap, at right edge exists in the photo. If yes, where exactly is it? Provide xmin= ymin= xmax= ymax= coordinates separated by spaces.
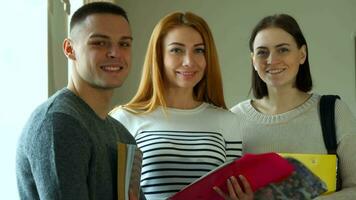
xmin=317 ymin=100 xmax=356 ymax=200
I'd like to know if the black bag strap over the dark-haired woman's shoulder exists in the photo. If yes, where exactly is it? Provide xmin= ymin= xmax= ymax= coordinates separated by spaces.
xmin=319 ymin=95 xmax=342 ymax=191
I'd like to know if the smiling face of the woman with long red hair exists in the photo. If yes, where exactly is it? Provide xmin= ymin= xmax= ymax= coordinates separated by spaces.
xmin=163 ymin=26 xmax=206 ymax=91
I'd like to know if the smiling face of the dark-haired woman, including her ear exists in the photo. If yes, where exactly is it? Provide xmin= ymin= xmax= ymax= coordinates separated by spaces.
xmin=252 ymin=27 xmax=306 ymax=88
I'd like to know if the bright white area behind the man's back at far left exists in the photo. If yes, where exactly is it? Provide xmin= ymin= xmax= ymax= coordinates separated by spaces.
xmin=0 ymin=0 xmax=48 ymax=199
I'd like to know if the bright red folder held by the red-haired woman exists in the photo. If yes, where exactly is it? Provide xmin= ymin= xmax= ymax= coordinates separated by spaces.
xmin=169 ymin=153 xmax=294 ymax=200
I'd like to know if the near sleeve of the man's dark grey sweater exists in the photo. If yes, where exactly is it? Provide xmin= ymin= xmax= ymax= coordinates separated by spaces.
xmin=29 ymin=113 xmax=91 ymax=199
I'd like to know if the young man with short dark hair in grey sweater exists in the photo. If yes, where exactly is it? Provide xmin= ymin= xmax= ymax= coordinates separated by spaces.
xmin=16 ymin=2 xmax=140 ymax=200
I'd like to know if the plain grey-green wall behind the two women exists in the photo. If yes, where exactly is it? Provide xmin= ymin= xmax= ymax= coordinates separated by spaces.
xmin=115 ymin=0 xmax=356 ymax=115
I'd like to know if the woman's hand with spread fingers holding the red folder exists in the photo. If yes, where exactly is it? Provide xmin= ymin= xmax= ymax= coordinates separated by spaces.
xmin=213 ymin=175 xmax=253 ymax=200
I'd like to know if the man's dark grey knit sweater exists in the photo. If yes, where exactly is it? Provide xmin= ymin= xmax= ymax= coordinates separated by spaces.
xmin=16 ymin=88 xmax=135 ymax=200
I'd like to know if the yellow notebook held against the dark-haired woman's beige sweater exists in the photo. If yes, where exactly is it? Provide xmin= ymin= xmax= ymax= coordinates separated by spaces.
xmin=279 ymin=153 xmax=337 ymax=194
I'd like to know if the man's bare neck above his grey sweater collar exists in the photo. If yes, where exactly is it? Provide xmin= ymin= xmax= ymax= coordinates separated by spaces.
xmin=67 ymin=81 xmax=114 ymax=119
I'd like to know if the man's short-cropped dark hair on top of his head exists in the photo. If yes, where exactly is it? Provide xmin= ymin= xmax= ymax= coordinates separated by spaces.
xmin=70 ymin=2 xmax=129 ymax=30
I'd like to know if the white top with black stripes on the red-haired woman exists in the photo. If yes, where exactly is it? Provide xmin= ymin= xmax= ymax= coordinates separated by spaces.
xmin=112 ymin=103 xmax=242 ymax=200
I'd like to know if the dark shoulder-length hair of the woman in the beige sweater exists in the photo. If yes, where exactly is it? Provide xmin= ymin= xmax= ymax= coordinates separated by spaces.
xmin=249 ymin=14 xmax=313 ymax=99
